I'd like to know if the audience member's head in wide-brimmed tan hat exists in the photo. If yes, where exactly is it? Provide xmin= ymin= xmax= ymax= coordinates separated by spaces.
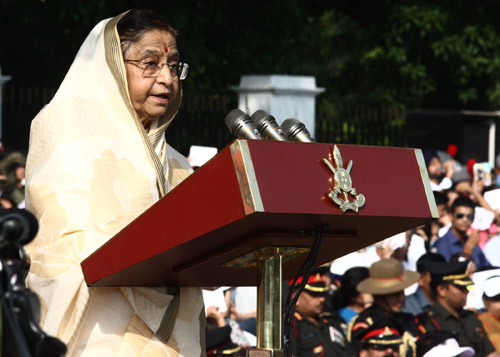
xmin=358 ymin=258 xmax=420 ymax=315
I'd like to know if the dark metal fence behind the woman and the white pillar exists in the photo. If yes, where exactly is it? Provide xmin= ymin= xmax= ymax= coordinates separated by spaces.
xmin=2 ymin=82 xmax=500 ymax=160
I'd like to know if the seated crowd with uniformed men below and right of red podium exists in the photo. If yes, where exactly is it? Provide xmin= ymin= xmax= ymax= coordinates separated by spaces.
xmin=204 ymin=146 xmax=500 ymax=357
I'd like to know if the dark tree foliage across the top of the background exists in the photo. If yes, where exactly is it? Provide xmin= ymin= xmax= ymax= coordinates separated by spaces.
xmin=0 ymin=0 xmax=500 ymax=110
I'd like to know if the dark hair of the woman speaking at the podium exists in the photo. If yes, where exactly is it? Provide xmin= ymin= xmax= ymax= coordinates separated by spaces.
xmin=116 ymin=9 xmax=179 ymax=58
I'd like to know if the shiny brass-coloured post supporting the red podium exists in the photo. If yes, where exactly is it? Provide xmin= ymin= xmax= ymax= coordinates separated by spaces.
xmin=257 ymin=248 xmax=282 ymax=351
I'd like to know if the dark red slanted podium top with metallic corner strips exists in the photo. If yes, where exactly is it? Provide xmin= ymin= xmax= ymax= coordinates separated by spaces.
xmin=82 ymin=140 xmax=437 ymax=286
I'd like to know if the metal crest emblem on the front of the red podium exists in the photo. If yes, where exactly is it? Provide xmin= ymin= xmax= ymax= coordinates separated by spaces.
xmin=323 ymin=145 xmax=365 ymax=213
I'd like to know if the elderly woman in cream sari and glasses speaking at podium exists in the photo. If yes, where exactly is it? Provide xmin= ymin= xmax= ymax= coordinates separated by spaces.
xmin=26 ymin=10 xmax=204 ymax=356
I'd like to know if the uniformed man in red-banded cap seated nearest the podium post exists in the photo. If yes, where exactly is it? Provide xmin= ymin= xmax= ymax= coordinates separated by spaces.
xmin=289 ymin=271 xmax=355 ymax=357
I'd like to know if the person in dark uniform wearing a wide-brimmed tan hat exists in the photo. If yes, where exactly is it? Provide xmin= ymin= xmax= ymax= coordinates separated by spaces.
xmin=347 ymin=258 xmax=420 ymax=356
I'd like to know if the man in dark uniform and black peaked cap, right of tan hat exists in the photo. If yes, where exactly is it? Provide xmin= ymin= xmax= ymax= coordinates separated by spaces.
xmin=416 ymin=262 xmax=500 ymax=357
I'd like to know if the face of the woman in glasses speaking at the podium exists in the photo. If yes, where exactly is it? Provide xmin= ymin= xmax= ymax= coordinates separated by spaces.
xmin=125 ymin=29 xmax=179 ymax=127
